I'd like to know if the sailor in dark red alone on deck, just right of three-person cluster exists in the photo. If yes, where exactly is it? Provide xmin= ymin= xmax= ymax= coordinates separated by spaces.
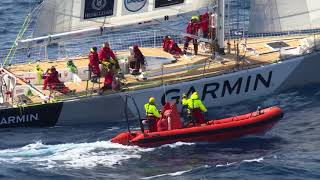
xmin=129 ymin=44 xmax=145 ymax=75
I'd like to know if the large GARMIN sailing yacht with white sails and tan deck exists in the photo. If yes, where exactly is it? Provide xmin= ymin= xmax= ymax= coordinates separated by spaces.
xmin=0 ymin=0 xmax=320 ymax=128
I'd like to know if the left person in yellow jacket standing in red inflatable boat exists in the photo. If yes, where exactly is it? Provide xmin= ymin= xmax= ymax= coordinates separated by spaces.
xmin=144 ymin=97 xmax=160 ymax=132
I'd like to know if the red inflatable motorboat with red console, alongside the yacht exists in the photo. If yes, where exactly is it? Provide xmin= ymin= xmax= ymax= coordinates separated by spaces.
xmin=111 ymin=104 xmax=283 ymax=147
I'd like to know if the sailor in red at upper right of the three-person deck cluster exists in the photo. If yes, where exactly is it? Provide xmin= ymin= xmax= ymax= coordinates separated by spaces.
xmin=99 ymin=42 xmax=120 ymax=70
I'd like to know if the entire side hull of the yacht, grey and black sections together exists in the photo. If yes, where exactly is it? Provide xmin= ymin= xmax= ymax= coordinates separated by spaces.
xmin=0 ymin=52 xmax=320 ymax=128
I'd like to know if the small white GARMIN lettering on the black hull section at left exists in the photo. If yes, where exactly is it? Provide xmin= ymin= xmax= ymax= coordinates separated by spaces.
xmin=0 ymin=113 xmax=40 ymax=125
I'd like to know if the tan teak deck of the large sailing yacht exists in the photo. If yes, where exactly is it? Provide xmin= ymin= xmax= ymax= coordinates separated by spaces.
xmin=7 ymin=36 xmax=306 ymax=103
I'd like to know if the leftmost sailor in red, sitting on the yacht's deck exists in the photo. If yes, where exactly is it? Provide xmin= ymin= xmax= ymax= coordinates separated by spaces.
xmin=43 ymin=66 xmax=73 ymax=94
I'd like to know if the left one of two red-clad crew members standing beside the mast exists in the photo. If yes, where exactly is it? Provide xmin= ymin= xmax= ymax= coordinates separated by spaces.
xmin=184 ymin=16 xmax=199 ymax=55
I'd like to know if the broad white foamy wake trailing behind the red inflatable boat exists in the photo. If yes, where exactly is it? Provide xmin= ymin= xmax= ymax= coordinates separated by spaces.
xmin=0 ymin=141 xmax=154 ymax=169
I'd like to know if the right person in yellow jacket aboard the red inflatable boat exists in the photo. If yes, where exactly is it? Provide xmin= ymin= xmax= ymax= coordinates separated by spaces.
xmin=182 ymin=92 xmax=207 ymax=124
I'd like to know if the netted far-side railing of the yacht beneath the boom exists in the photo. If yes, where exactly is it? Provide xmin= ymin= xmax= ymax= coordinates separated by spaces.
xmin=0 ymin=30 xmax=184 ymax=65
